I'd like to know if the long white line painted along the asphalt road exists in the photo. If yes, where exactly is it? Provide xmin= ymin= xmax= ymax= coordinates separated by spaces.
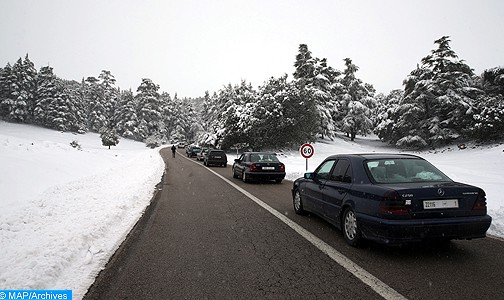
xmin=179 ymin=152 xmax=407 ymax=300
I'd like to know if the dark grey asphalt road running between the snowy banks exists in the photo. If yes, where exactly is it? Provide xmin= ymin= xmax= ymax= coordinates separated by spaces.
xmin=85 ymin=148 xmax=504 ymax=299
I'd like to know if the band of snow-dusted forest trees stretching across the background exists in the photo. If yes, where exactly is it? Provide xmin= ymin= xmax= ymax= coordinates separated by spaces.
xmin=0 ymin=36 xmax=504 ymax=149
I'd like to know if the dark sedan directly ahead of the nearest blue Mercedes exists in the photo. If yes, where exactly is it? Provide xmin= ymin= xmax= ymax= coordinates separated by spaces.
xmin=233 ymin=152 xmax=285 ymax=183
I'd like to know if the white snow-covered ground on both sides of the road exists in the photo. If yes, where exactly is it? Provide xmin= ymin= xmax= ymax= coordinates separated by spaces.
xmin=0 ymin=121 xmax=504 ymax=299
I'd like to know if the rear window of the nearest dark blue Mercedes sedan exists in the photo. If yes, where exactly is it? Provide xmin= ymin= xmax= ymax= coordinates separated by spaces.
xmin=364 ymin=158 xmax=452 ymax=183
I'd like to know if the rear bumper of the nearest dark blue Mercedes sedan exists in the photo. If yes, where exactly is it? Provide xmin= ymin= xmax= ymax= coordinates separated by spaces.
xmin=357 ymin=215 xmax=492 ymax=244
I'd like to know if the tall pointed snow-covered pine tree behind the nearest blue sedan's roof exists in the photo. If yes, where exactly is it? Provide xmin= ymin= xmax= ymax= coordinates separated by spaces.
xmin=392 ymin=36 xmax=482 ymax=147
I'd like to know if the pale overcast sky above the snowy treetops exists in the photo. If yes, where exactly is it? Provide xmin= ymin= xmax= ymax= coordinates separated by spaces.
xmin=0 ymin=0 xmax=504 ymax=98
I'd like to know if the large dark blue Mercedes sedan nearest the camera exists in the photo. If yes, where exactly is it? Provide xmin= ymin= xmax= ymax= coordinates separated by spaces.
xmin=292 ymin=154 xmax=492 ymax=246
